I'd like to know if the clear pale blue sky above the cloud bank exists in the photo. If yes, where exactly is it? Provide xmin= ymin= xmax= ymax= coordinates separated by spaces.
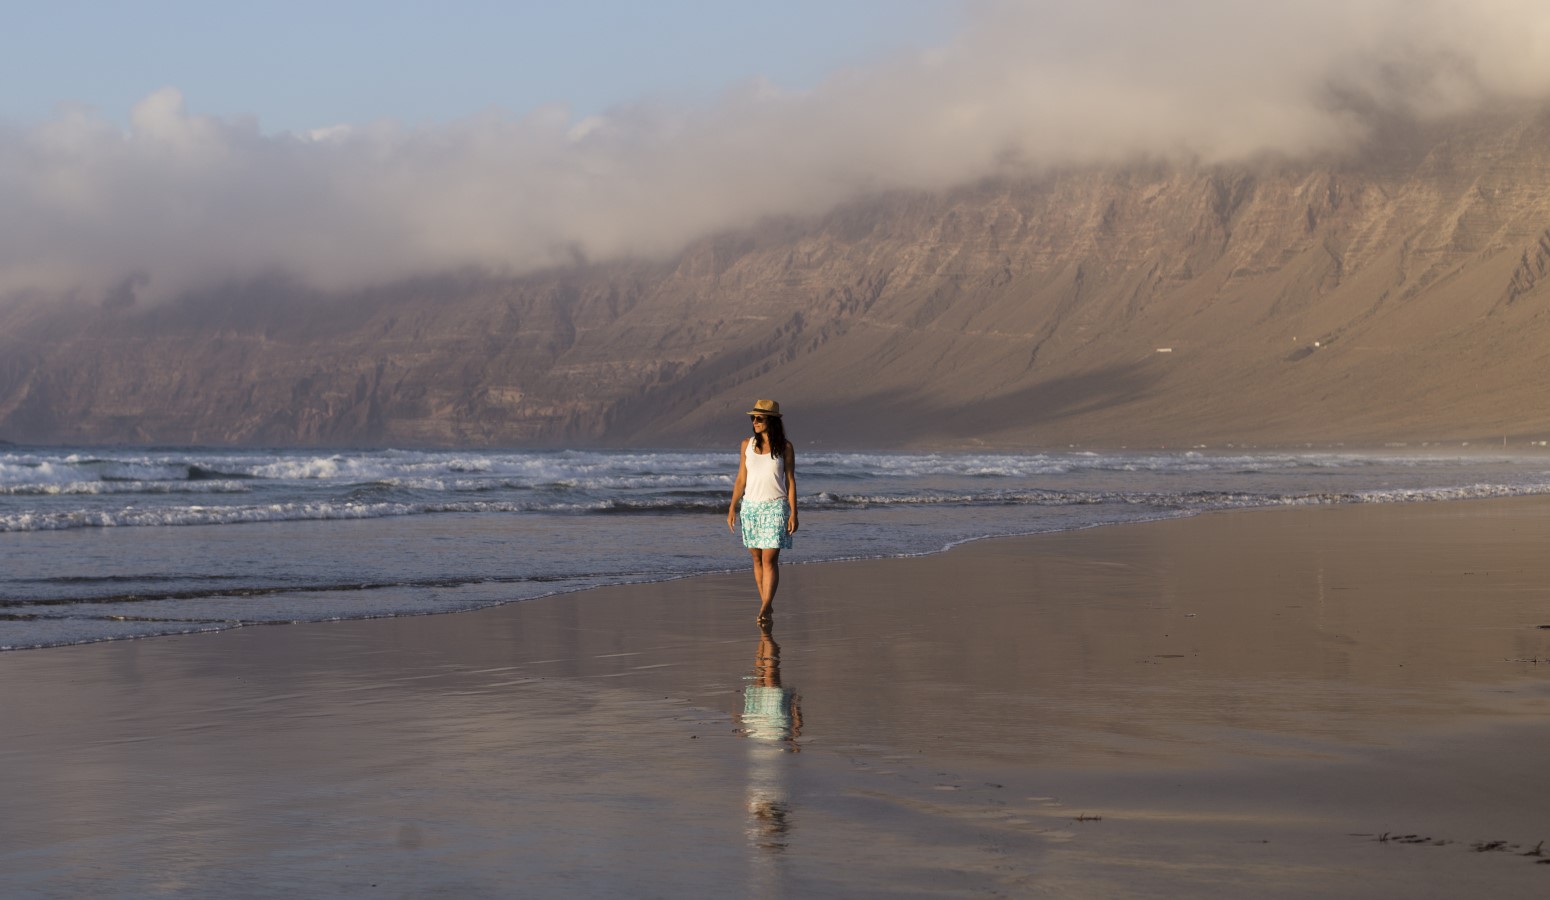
xmin=0 ymin=0 xmax=961 ymax=133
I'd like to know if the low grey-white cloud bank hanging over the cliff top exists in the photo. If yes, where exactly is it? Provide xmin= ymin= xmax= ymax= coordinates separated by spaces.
xmin=0 ymin=0 xmax=1550 ymax=297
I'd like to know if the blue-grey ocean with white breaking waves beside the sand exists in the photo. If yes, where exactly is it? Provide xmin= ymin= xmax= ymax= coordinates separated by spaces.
xmin=0 ymin=445 xmax=1550 ymax=649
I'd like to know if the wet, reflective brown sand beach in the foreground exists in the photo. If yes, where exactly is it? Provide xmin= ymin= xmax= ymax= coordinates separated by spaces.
xmin=0 ymin=499 xmax=1550 ymax=897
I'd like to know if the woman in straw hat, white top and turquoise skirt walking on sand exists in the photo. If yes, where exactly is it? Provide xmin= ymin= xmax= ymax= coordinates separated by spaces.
xmin=727 ymin=400 xmax=797 ymax=621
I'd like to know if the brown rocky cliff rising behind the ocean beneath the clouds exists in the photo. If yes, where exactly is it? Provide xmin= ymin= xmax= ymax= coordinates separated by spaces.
xmin=0 ymin=108 xmax=1550 ymax=448
